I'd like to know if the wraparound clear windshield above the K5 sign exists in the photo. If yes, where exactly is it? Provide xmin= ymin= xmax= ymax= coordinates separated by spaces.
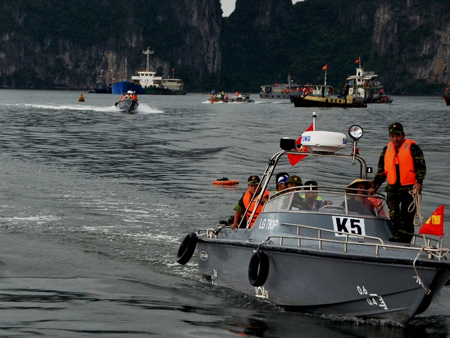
xmin=263 ymin=187 xmax=389 ymax=219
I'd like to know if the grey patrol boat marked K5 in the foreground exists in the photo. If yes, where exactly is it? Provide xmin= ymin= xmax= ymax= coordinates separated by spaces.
xmin=177 ymin=115 xmax=450 ymax=326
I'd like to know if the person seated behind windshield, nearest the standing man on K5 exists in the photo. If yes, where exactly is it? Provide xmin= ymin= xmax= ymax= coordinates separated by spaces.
xmin=342 ymin=178 xmax=375 ymax=216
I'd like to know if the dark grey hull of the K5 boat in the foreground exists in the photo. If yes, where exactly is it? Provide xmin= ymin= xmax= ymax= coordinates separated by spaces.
xmin=197 ymin=239 xmax=450 ymax=326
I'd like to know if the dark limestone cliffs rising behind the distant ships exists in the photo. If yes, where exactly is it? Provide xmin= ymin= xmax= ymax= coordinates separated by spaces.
xmin=0 ymin=0 xmax=450 ymax=94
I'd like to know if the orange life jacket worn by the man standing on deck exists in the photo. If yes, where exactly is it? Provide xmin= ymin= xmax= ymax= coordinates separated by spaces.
xmin=384 ymin=139 xmax=417 ymax=185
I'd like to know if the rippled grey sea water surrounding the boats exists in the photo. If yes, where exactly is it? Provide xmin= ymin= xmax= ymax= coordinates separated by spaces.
xmin=0 ymin=90 xmax=450 ymax=337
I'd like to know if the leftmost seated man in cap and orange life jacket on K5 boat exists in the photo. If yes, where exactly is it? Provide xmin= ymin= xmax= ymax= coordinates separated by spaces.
xmin=231 ymin=175 xmax=270 ymax=230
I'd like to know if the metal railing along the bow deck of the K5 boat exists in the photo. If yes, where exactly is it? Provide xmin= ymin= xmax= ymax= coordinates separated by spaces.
xmin=264 ymin=222 xmax=449 ymax=261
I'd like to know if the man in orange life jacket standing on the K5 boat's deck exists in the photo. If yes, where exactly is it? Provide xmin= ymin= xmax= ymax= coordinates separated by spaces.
xmin=369 ymin=122 xmax=427 ymax=243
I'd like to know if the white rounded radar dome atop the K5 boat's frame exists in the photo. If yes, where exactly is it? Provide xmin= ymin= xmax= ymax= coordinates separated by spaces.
xmin=302 ymin=131 xmax=347 ymax=153
